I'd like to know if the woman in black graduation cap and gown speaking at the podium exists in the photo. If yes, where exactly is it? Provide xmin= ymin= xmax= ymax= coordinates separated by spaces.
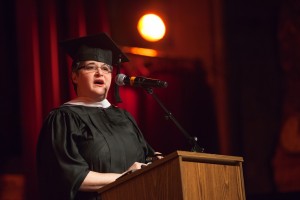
xmin=37 ymin=34 xmax=162 ymax=200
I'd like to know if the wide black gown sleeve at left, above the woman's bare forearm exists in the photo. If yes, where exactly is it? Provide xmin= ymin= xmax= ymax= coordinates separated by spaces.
xmin=37 ymin=110 xmax=89 ymax=199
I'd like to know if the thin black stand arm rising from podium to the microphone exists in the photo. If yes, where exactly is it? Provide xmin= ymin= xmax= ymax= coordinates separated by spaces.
xmin=143 ymin=87 xmax=204 ymax=153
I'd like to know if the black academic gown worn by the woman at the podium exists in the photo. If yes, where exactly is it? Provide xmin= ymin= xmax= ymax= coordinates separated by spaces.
xmin=37 ymin=105 xmax=154 ymax=200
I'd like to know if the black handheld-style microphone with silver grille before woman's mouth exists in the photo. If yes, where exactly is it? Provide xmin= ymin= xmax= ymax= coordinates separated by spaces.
xmin=115 ymin=74 xmax=168 ymax=88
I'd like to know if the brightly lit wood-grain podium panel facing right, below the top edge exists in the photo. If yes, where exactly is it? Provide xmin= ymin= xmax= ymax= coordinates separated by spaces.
xmin=181 ymin=161 xmax=245 ymax=200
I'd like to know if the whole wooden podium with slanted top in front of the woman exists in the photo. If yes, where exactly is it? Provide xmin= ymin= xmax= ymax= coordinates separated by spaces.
xmin=99 ymin=151 xmax=246 ymax=200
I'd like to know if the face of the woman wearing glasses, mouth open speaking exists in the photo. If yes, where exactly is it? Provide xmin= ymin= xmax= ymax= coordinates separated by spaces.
xmin=72 ymin=60 xmax=112 ymax=101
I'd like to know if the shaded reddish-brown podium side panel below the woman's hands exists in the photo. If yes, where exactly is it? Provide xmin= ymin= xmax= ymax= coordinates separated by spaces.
xmin=100 ymin=159 xmax=183 ymax=200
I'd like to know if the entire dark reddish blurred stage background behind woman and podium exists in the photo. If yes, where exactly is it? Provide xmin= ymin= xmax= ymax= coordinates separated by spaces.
xmin=0 ymin=0 xmax=300 ymax=200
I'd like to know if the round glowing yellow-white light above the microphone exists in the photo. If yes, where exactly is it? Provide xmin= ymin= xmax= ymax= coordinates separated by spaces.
xmin=137 ymin=14 xmax=166 ymax=42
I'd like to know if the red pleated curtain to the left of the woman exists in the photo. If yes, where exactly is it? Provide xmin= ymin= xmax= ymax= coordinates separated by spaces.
xmin=15 ymin=0 xmax=109 ymax=199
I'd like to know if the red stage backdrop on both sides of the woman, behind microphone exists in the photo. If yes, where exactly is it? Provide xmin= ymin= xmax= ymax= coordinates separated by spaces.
xmin=11 ymin=0 xmax=219 ymax=199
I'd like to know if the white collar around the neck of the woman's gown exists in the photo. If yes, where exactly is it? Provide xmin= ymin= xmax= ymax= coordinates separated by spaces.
xmin=64 ymin=97 xmax=111 ymax=108
